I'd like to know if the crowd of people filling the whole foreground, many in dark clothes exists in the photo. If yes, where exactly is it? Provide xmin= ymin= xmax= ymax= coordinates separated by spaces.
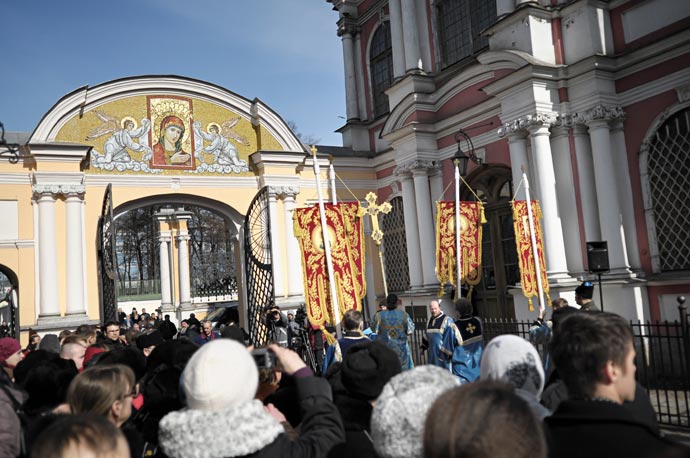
xmin=0 ymin=284 xmax=690 ymax=458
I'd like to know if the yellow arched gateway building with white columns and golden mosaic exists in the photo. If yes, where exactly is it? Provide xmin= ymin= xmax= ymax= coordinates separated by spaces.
xmin=0 ymin=76 xmax=375 ymax=339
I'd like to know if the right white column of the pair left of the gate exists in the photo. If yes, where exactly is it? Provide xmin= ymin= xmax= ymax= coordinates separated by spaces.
xmin=65 ymin=192 xmax=86 ymax=315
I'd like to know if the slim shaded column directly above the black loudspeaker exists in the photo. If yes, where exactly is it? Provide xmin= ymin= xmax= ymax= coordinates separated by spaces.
xmin=573 ymin=125 xmax=601 ymax=242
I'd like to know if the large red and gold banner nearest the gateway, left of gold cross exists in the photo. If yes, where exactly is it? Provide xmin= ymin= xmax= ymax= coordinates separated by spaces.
xmin=293 ymin=204 xmax=364 ymax=326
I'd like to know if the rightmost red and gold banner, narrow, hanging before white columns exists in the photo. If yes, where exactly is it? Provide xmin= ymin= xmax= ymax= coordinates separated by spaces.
xmin=512 ymin=200 xmax=551 ymax=311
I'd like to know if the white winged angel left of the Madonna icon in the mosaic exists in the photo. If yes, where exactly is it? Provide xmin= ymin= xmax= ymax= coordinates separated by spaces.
xmin=86 ymin=110 xmax=152 ymax=164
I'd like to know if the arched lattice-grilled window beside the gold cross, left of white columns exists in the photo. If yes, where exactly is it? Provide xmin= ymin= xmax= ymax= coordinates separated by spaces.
xmin=381 ymin=197 xmax=410 ymax=292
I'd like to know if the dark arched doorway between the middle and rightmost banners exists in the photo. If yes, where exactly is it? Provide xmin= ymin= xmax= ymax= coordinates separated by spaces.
xmin=461 ymin=165 xmax=520 ymax=318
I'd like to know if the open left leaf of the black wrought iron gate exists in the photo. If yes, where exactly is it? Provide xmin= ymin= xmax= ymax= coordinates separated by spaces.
xmin=98 ymin=184 xmax=117 ymax=323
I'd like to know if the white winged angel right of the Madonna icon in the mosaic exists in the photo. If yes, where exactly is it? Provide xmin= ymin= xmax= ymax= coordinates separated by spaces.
xmin=192 ymin=117 xmax=249 ymax=166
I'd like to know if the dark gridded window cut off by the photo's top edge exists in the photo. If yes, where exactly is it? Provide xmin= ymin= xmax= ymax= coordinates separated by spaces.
xmin=436 ymin=0 xmax=496 ymax=67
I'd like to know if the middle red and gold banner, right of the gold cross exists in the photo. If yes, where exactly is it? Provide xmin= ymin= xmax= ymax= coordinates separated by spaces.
xmin=436 ymin=201 xmax=486 ymax=290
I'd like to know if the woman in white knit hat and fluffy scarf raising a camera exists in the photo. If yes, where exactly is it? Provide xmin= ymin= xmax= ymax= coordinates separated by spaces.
xmin=158 ymin=339 xmax=345 ymax=458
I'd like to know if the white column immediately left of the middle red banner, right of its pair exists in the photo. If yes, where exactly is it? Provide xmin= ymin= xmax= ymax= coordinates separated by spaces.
xmin=412 ymin=166 xmax=438 ymax=286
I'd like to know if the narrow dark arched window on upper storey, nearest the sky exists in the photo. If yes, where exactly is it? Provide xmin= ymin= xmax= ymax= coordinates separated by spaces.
xmin=369 ymin=22 xmax=393 ymax=118
